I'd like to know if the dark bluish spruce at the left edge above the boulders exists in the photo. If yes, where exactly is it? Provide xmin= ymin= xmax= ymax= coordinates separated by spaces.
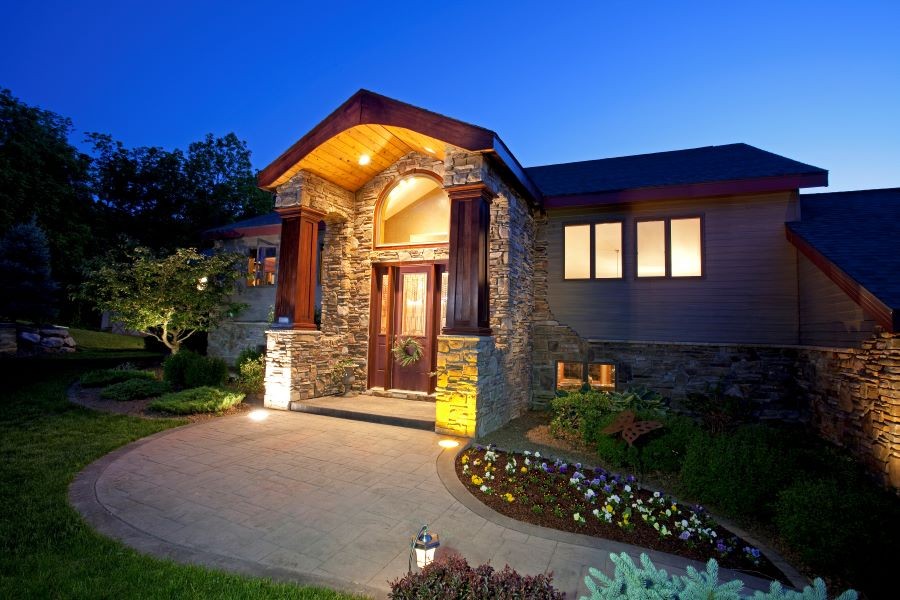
xmin=0 ymin=219 xmax=57 ymax=323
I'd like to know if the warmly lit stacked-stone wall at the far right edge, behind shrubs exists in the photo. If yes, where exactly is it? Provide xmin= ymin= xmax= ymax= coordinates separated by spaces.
xmin=800 ymin=332 xmax=900 ymax=491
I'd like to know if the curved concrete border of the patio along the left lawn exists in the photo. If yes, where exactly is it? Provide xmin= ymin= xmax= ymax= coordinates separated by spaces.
xmin=68 ymin=415 xmax=384 ymax=598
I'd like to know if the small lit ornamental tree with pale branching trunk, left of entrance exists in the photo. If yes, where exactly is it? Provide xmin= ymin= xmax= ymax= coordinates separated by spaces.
xmin=82 ymin=247 xmax=245 ymax=354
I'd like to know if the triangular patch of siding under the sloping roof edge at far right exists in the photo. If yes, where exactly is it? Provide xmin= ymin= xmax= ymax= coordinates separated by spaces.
xmin=799 ymin=254 xmax=875 ymax=348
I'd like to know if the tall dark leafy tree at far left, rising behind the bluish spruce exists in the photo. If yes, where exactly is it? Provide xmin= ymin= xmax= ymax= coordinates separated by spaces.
xmin=0 ymin=89 xmax=99 ymax=316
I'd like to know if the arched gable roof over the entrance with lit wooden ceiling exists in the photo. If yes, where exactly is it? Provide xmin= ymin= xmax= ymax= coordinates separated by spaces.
xmin=259 ymin=90 xmax=541 ymax=202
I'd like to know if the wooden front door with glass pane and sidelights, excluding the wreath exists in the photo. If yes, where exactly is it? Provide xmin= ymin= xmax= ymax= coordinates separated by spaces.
xmin=369 ymin=264 xmax=446 ymax=393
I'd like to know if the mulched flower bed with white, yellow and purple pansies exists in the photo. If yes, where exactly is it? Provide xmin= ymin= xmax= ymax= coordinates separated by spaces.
xmin=456 ymin=446 xmax=787 ymax=581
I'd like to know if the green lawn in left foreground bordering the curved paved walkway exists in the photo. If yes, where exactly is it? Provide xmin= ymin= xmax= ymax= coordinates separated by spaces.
xmin=0 ymin=361 xmax=366 ymax=600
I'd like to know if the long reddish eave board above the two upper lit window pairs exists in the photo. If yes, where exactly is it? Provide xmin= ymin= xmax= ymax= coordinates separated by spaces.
xmin=544 ymin=171 xmax=828 ymax=209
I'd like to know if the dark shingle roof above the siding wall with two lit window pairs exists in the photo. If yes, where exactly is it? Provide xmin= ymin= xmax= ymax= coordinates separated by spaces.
xmin=525 ymin=144 xmax=827 ymax=196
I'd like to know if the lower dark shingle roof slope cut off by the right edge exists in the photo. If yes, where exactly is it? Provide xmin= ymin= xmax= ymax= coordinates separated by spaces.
xmin=788 ymin=188 xmax=900 ymax=310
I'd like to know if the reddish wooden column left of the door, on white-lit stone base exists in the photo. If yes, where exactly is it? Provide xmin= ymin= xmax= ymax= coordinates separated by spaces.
xmin=275 ymin=206 xmax=325 ymax=329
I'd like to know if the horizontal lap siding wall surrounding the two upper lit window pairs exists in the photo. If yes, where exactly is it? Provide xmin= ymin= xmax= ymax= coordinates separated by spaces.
xmin=547 ymin=193 xmax=798 ymax=344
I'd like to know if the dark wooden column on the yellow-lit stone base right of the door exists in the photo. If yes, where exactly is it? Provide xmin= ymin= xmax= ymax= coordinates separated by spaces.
xmin=443 ymin=183 xmax=494 ymax=335
